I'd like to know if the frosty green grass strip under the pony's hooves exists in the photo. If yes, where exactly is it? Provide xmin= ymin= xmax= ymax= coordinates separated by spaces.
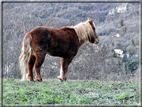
xmin=3 ymin=79 xmax=140 ymax=105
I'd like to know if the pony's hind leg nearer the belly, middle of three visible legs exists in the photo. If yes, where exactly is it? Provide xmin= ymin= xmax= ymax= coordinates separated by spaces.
xmin=35 ymin=51 xmax=46 ymax=82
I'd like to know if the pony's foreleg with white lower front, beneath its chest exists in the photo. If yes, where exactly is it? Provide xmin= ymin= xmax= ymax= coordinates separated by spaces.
xmin=58 ymin=57 xmax=73 ymax=81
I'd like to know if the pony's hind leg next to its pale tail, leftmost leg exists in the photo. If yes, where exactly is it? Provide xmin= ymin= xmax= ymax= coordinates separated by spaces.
xmin=27 ymin=51 xmax=36 ymax=81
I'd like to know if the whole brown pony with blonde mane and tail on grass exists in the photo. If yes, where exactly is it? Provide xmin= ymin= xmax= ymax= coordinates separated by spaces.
xmin=19 ymin=20 xmax=99 ymax=81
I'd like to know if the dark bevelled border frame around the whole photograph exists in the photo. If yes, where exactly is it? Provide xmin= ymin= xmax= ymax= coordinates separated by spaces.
xmin=0 ymin=0 xmax=142 ymax=107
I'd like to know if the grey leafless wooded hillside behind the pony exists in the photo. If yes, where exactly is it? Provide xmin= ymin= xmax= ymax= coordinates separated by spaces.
xmin=1 ymin=3 xmax=140 ymax=82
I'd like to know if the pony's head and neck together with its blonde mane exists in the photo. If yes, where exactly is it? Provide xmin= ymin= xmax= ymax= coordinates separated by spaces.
xmin=74 ymin=20 xmax=99 ymax=44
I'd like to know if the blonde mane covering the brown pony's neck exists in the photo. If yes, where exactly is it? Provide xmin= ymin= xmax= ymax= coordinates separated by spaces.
xmin=73 ymin=20 xmax=94 ymax=44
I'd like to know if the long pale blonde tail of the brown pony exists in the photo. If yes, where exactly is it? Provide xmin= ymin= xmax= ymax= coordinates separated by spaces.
xmin=19 ymin=33 xmax=32 ymax=81
